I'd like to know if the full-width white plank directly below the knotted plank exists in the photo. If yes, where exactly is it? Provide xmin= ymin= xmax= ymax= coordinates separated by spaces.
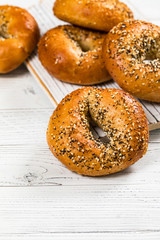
xmin=0 ymin=184 xmax=160 ymax=236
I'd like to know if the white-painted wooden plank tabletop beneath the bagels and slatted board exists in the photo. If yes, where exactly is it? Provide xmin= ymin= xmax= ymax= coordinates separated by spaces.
xmin=0 ymin=0 xmax=160 ymax=240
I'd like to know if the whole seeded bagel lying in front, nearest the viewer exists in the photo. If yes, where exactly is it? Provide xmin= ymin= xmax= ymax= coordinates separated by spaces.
xmin=47 ymin=87 xmax=149 ymax=176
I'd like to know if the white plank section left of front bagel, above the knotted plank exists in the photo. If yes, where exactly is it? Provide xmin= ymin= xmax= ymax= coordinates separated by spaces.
xmin=0 ymin=109 xmax=52 ymax=145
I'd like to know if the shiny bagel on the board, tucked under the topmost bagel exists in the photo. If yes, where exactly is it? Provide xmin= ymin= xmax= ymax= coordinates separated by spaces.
xmin=38 ymin=25 xmax=111 ymax=85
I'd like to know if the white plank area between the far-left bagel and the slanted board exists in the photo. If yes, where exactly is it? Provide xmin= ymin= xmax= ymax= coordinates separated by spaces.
xmin=0 ymin=65 xmax=53 ymax=109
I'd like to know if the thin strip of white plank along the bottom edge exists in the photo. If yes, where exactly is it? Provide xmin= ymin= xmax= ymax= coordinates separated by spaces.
xmin=0 ymin=230 xmax=160 ymax=240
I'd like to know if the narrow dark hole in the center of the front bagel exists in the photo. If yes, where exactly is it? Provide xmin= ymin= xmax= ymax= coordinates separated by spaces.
xmin=89 ymin=117 xmax=110 ymax=144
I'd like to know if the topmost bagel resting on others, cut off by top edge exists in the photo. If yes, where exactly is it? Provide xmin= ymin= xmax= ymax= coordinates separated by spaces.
xmin=53 ymin=0 xmax=133 ymax=32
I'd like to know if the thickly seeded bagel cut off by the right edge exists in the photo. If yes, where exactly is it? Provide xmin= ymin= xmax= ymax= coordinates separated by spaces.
xmin=103 ymin=20 xmax=160 ymax=102
